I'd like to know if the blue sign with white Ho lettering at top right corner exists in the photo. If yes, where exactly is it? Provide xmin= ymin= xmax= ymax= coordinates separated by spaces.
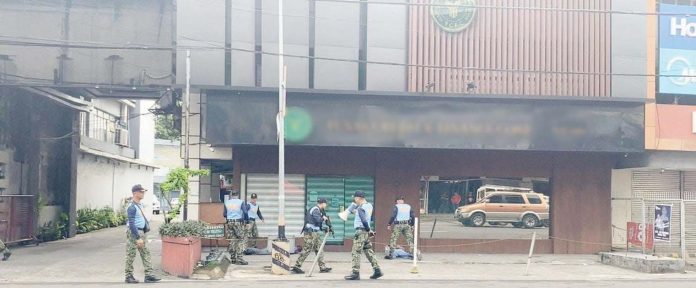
xmin=659 ymin=4 xmax=696 ymax=95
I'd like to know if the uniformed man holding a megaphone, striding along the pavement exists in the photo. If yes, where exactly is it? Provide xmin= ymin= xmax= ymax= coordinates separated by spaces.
xmin=345 ymin=191 xmax=384 ymax=280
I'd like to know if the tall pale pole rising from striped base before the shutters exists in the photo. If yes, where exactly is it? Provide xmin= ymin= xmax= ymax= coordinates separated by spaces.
xmin=277 ymin=0 xmax=286 ymax=240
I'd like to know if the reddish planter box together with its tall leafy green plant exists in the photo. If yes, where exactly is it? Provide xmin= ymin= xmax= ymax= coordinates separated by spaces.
xmin=159 ymin=168 xmax=208 ymax=277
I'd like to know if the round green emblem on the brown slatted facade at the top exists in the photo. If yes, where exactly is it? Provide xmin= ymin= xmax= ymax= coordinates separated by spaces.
xmin=430 ymin=0 xmax=476 ymax=33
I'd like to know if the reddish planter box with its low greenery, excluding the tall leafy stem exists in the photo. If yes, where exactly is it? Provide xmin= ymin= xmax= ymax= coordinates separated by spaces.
xmin=159 ymin=221 xmax=205 ymax=277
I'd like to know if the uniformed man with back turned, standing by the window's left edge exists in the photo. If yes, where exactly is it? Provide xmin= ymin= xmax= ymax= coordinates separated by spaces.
xmin=384 ymin=196 xmax=415 ymax=260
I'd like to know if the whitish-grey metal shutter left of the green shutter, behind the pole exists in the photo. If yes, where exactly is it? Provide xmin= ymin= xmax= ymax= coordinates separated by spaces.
xmin=246 ymin=174 xmax=305 ymax=239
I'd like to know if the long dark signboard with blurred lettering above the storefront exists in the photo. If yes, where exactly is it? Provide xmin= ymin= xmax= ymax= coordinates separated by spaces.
xmin=205 ymin=91 xmax=645 ymax=152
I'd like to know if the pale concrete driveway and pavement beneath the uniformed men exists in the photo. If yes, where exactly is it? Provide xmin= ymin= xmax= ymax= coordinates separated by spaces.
xmin=0 ymin=227 xmax=696 ymax=285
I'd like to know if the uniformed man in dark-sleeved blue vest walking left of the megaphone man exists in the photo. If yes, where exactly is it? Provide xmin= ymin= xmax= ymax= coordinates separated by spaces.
xmin=291 ymin=198 xmax=331 ymax=274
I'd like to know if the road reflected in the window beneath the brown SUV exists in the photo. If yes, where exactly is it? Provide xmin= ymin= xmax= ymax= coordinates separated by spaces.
xmin=420 ymin=214 xmax=549 ymax=239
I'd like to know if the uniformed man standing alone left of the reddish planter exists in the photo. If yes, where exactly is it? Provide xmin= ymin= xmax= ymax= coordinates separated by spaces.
xmin=126 ymin=184 xmax=161 ymax=283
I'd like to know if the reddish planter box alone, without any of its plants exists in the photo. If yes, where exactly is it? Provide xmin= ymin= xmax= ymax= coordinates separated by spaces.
xmin=162 ymin=237 xmax=201 ymax=278
